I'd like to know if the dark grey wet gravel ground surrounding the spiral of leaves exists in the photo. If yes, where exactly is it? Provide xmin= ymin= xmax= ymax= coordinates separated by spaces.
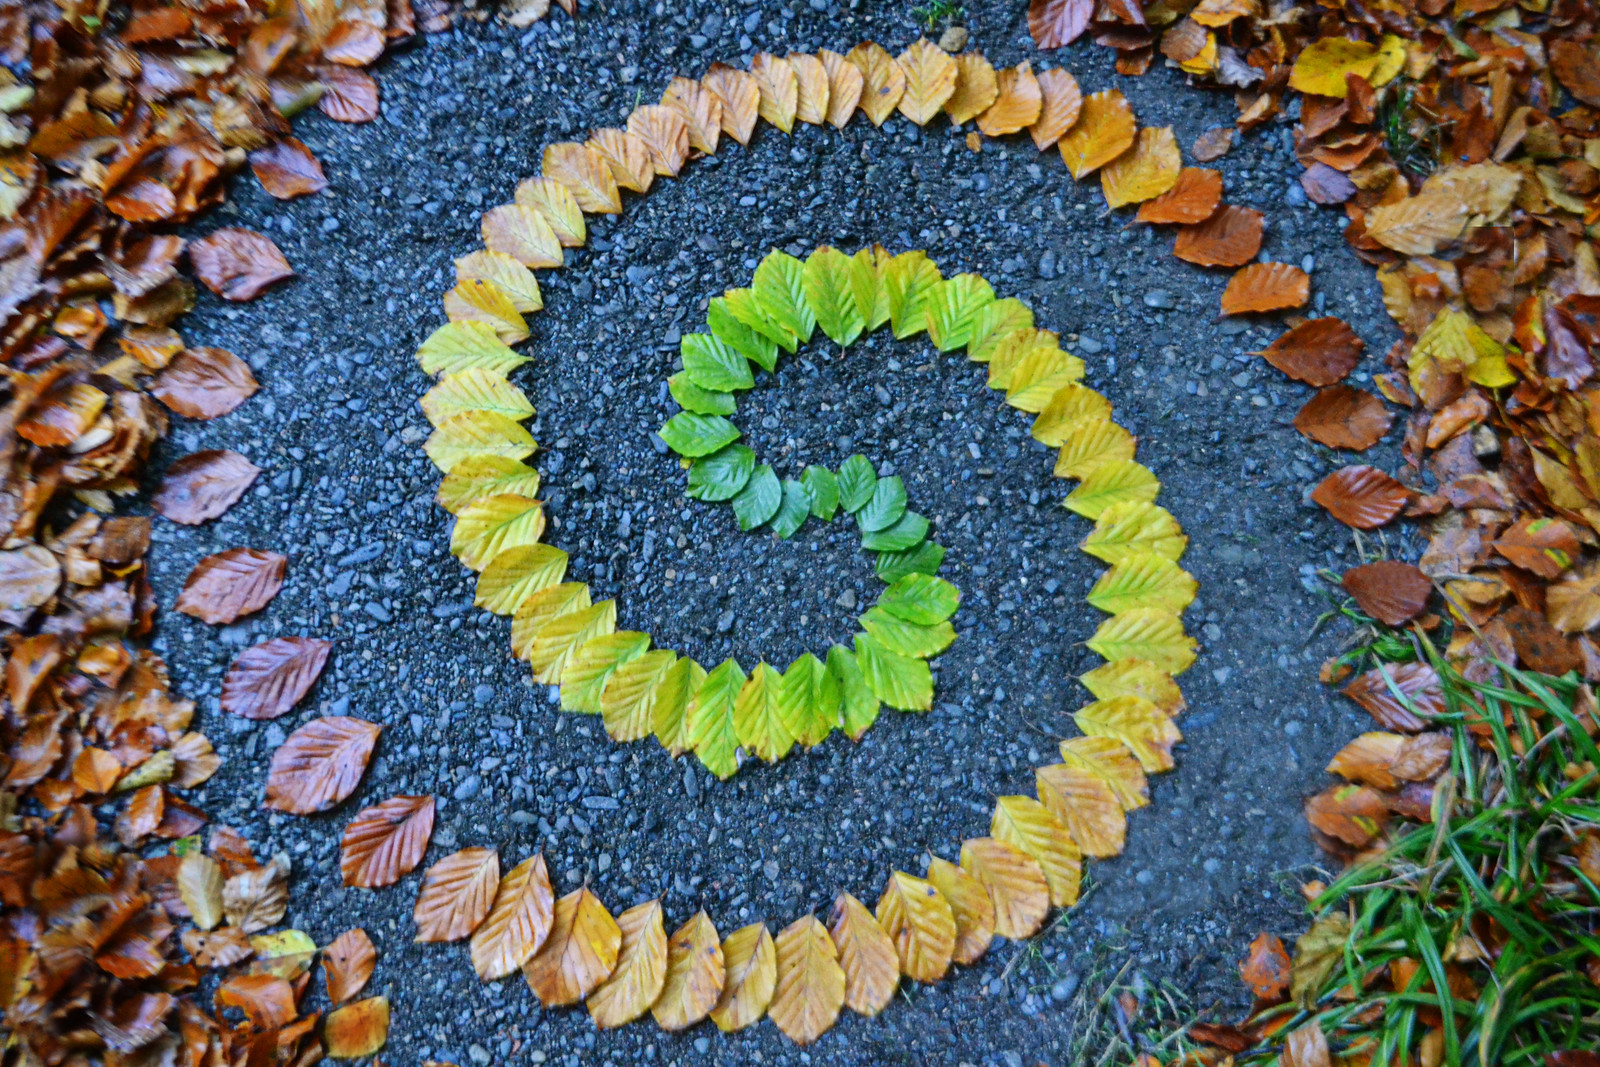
xmin=154 ymin=0 xmax=1392 ymax=1067
